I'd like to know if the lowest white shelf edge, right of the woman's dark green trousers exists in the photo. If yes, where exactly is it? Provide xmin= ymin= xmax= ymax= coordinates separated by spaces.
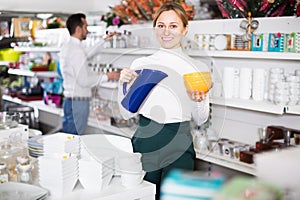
xmin=195 ymin=149 xmax=256 ymax=175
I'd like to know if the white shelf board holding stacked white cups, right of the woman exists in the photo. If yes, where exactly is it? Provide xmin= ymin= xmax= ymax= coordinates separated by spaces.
xmin=211 ymin=98 xmax=284 ymax=115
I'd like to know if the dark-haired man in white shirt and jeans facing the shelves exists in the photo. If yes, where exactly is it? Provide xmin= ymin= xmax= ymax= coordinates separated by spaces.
xmin=60 ymin=13 xmax=120 ymax=135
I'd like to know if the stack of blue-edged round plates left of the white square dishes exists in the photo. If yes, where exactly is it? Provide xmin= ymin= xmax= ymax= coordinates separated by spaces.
xmin=27 ymin=135 xmax=44 ymax=158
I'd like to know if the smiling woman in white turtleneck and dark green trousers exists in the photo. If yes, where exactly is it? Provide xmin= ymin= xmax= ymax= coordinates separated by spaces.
xmin=119 ymin=2 xmax=209 ymax=198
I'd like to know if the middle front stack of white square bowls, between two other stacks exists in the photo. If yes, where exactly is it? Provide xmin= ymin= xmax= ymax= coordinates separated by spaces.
xmin=79 ymin=157 xmax=114 ymax=190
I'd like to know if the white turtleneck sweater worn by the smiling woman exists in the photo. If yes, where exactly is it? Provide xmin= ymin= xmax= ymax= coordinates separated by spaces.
xmin=119 ymin=48 xmax=209 ymax=125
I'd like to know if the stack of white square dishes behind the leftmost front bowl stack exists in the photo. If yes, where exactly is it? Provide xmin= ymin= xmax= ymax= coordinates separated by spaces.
xmin=43 ymin=133 xmax=80 ymax=155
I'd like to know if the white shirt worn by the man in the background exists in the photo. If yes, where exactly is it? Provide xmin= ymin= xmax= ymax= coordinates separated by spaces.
xmin=59 ymin=37 xmax=107 ymax=97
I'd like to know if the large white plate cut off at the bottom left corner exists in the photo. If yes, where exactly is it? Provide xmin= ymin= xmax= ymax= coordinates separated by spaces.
xmin=0 ymin=182 xmax=48 ymax=200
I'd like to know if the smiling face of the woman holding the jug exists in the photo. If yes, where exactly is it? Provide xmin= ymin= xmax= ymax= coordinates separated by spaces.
xmin=155 ymin=10 xmax=187 ymax=49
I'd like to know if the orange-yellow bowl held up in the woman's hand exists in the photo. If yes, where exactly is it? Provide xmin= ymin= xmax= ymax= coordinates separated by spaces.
xmin=183 ymin=72 xmax=212 ymax=93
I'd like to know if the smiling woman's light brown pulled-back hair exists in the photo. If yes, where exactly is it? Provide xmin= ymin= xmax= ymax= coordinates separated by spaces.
xmin=153 ymin=2 xmax=189 ymax=27
